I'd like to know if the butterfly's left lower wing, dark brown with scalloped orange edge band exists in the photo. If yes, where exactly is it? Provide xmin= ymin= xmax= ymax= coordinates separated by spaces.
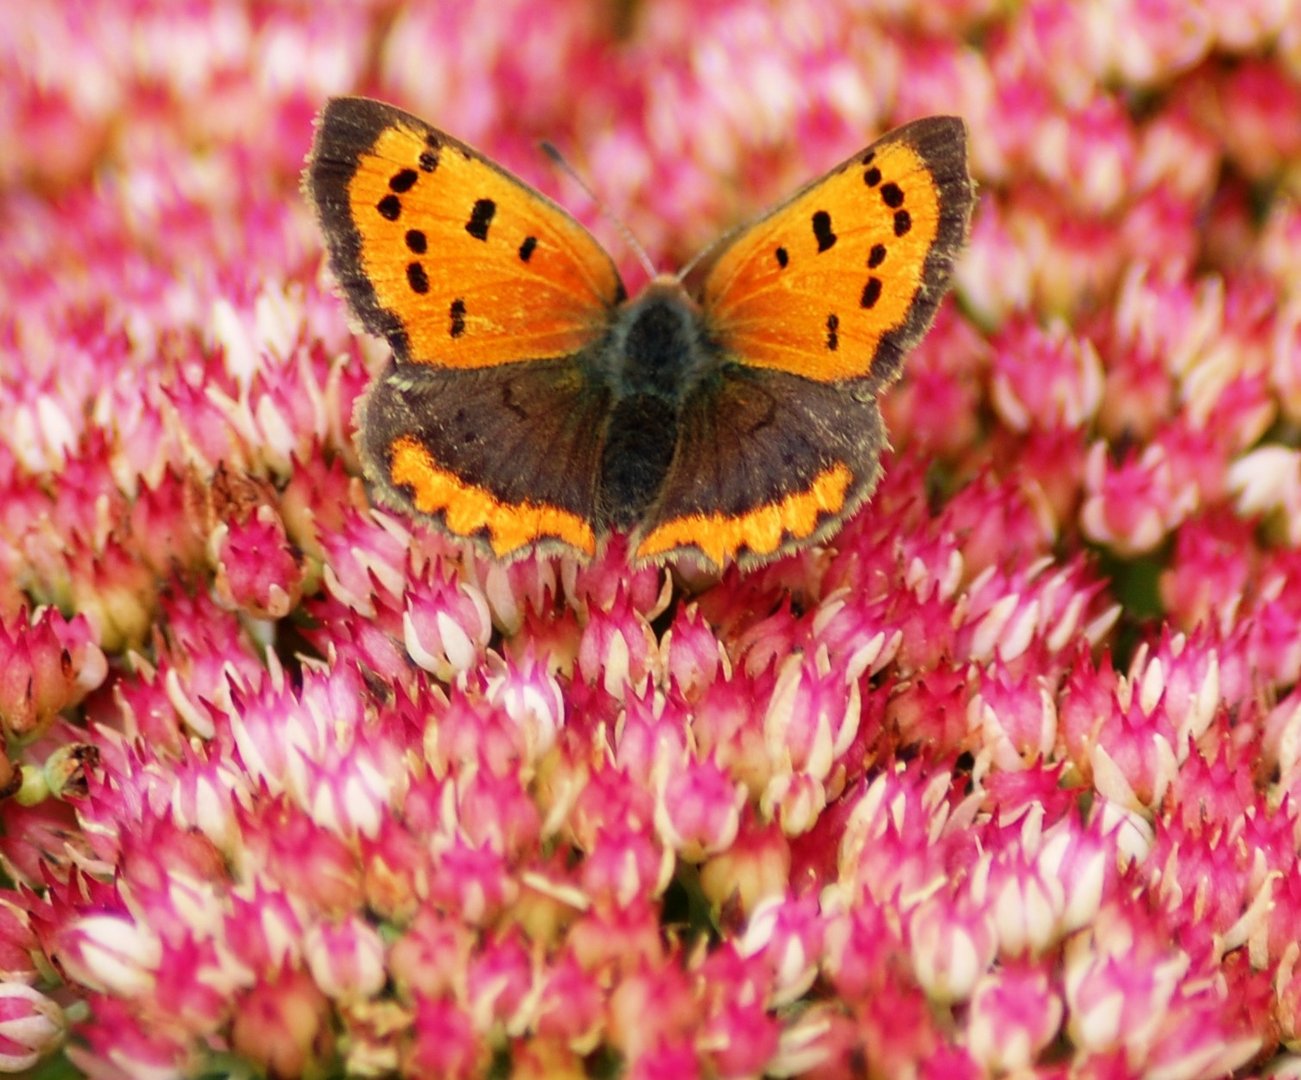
xmin=358 ymin=359 xmax=609 ymax=558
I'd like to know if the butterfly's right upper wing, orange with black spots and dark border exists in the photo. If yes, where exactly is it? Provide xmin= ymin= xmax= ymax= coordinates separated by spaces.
xmin=701 ymin=116 xmax=973 ymax=386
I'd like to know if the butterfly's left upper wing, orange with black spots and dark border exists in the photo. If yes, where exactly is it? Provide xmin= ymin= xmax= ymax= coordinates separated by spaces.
xmin=304 ymin=98 xmax=623 ymax=368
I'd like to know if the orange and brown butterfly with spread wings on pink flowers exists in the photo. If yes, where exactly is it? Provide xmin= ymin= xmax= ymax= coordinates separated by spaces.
xmin=303 ymin=98 xmax=973 ymax=569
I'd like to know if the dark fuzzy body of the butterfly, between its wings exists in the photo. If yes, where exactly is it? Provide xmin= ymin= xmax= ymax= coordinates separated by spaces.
xmin=598 ymin=278 xmax=721 ymax=528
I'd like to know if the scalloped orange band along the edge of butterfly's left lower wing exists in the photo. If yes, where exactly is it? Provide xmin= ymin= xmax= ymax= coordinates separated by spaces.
xmin=389 ymin=437 xmax=596 ymax=558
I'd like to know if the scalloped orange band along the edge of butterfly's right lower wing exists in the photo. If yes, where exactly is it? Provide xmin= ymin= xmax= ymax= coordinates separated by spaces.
xmin=636 ymin=463 xmax=853 ymax=567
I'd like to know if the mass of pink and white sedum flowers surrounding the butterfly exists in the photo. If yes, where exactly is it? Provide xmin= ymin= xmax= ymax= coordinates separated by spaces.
xmin=0 ymin=0 xmax=1301 ymax=1080
